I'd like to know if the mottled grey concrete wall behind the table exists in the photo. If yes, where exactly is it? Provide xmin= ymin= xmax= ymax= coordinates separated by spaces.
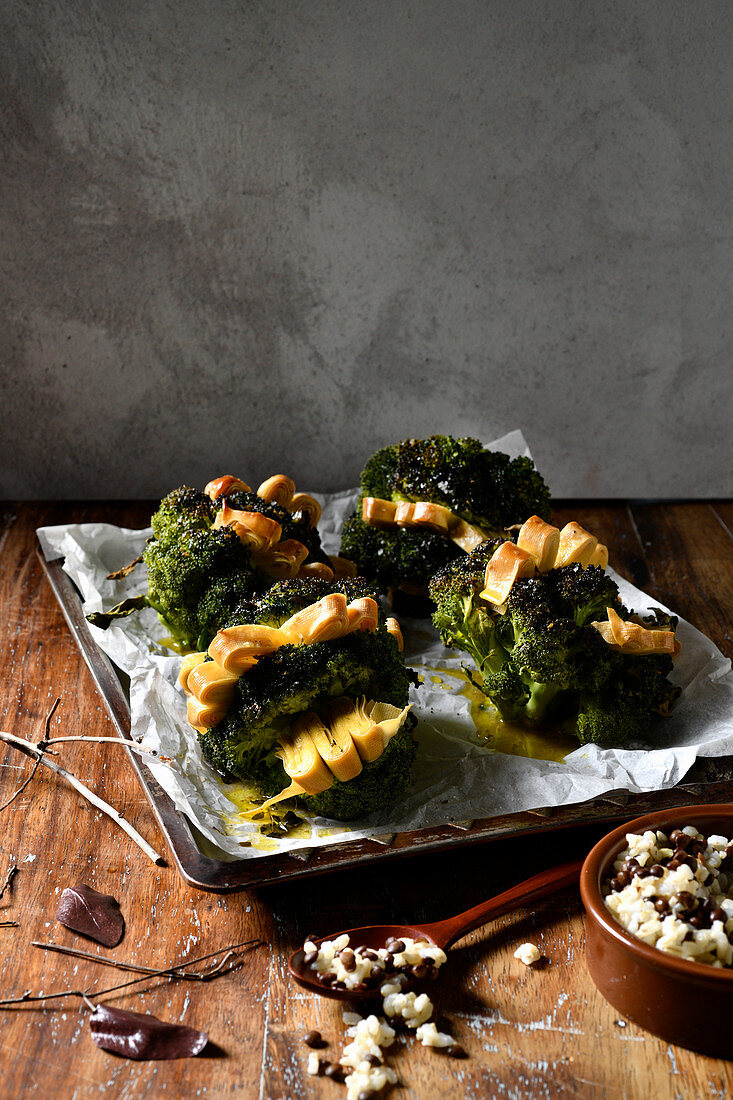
xmin=0 ymin=0 xmax=733 ymax=497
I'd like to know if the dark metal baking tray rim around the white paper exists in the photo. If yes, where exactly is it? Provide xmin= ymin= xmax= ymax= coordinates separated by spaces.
xmin=36 ymin=547 xmax=733 ymax=893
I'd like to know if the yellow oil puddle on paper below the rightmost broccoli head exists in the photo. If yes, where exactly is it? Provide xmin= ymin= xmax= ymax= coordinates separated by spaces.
xmin=430 ymin=669 xmax=578 ymax=763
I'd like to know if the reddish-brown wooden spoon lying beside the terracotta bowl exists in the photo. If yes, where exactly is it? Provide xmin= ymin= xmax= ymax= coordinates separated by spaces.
xmin=287 ymin=859 xmax=583 ymax=1001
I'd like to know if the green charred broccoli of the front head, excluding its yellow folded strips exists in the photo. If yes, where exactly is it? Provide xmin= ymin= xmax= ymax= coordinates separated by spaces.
xmin=193 ymin=580 xmax=416 ymax=820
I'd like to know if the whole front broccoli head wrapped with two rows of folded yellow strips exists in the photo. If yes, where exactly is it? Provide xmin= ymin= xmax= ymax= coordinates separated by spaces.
xmin=182 ymin=579 xmax=416 ymax=821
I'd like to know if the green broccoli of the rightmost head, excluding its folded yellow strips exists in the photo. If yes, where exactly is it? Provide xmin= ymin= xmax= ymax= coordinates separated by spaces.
xmin=430 ymin=546 xmax=679 ymax=745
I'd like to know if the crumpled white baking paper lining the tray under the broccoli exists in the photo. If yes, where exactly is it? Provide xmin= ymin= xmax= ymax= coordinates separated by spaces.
xmin=37 ymin=432 xmax=733 ymax=859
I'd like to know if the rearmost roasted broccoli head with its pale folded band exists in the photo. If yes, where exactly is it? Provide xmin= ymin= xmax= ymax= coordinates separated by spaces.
xmin=341 ymin=436 xmax=549 ymax=589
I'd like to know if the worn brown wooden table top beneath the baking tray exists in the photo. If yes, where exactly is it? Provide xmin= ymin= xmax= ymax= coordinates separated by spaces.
xmin=0 ymin=503 xmax=733 ymax=1100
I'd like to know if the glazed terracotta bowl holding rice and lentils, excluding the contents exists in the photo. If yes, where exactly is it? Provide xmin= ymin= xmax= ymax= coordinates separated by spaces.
xmin=580 ymin=805 xmax=733 ymax=1058
